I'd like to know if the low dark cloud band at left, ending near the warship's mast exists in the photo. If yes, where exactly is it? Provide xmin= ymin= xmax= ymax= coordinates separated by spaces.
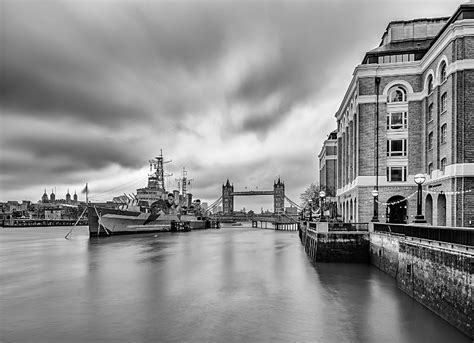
xmin=0 ymin=120 xmax=149 ymax=191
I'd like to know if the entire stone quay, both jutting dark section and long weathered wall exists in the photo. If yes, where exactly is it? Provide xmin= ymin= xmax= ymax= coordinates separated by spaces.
xmin=300 ymin=223 xmax=474 ymax=339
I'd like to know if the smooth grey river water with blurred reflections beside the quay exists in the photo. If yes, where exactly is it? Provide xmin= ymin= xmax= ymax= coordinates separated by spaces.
xmin=0 ymin=227 xmax=470 ymax=343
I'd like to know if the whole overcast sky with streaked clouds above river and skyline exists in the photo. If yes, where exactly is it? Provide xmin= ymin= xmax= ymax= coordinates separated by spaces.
xmin=0 ymin=0 xmax=462 ymax=210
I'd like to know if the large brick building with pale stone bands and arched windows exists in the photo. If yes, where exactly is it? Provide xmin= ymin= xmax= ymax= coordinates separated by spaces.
xmin=326 ymin=3 xmax=474 ymax=227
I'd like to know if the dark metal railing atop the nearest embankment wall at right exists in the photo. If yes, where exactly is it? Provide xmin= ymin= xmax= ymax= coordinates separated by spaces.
xmin=374 ymin=223 xmax=474 ymax=246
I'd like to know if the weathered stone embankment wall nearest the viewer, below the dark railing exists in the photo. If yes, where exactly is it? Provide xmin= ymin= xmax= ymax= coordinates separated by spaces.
xmin=370 ymin=232 xmax=474 ymax=338
